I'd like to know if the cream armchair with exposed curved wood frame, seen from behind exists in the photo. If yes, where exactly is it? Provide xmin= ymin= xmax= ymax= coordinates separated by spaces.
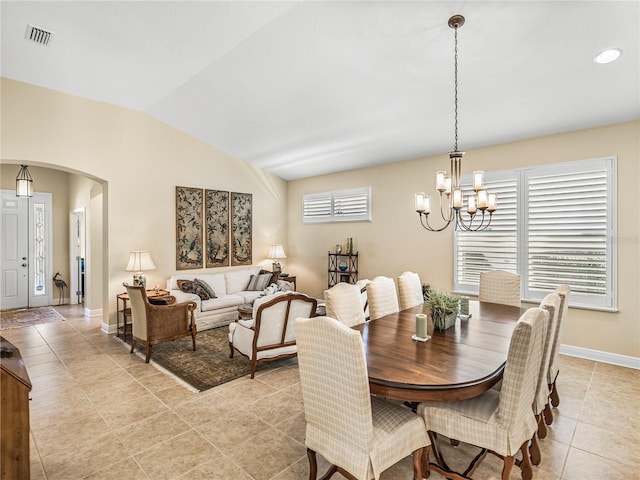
xmin=229 ymin=292 xmax=317 ymax=378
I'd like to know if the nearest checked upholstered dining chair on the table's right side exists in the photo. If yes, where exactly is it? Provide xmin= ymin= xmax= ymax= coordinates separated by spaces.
xmin=417 ymin=308 xmax=549 ymax=480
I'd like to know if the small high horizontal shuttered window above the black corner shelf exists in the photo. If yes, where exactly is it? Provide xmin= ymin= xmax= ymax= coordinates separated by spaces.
xmin=302 ymin=187 xmax=371 ymax=223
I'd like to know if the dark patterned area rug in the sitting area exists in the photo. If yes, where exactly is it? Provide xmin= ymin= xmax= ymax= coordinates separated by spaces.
xmin=127 ymin=326 xmax=284 ymax=391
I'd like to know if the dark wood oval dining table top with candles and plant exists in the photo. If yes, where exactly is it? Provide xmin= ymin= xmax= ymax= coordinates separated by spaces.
xmin=353 ymin=301 xmax=526 ymax=402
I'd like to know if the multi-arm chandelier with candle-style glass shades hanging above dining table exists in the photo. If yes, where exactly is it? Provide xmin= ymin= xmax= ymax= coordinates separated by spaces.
xmin=416 ymin=15 xmax=498 ymax=232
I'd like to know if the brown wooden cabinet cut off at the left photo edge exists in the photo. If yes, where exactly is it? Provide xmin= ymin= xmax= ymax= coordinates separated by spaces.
xmin=0 ymin=337 xmax=31 ymax=480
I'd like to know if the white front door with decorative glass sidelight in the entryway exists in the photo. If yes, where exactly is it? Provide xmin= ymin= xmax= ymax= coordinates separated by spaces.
xmin=0 ymin=190 xmax=52 ymax=310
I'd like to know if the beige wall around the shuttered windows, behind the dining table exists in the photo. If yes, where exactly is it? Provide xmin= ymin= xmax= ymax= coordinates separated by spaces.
xmin=287 ymin=122 xmax=640 ymax=357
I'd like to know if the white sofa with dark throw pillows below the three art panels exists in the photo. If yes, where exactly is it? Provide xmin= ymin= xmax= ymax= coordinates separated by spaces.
xmin=167 ymin=267 xmax=264 ymax=330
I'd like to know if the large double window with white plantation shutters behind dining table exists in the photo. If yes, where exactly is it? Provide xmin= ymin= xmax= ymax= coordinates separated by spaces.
xmin=454 ymin=157 xmax=616 ymax=310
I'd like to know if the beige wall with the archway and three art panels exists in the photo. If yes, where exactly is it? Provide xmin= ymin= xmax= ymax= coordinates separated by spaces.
xmin=1 ymin=79 xmax=287 ymax=325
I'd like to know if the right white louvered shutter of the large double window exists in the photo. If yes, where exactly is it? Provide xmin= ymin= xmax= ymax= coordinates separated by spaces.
xmin=526 ymin=161 xmax=612 ymax=306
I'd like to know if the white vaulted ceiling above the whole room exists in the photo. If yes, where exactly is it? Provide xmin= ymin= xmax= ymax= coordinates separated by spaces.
xmin=0 ymin=0 xmax=640 ymax=180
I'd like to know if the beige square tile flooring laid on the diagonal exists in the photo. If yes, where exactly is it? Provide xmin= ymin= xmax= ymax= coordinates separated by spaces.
xmin=2 ymin=306 xmax=640 ymax=480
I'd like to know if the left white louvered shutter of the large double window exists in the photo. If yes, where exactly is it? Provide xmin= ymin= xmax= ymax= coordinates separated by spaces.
xmin=454 ymin=172 xmax=518 ymax=294
